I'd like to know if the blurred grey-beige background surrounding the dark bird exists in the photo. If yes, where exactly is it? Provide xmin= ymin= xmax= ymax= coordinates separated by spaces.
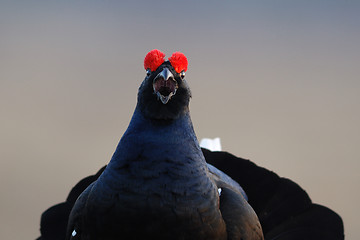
xmin=0 ymin=0 xmax=360 ymax=240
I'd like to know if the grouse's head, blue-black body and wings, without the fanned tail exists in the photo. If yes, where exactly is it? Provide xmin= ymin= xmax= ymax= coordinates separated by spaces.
xmin=62 ymin=49 xmax=264 ymax=240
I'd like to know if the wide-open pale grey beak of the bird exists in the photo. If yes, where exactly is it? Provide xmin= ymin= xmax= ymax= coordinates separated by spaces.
xmin=153 ymin=67 xmax=178 ymax=104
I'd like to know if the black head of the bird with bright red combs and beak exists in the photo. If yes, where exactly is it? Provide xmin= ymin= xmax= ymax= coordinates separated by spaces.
xmin=138 ymin=49 xmax=191 ymax=120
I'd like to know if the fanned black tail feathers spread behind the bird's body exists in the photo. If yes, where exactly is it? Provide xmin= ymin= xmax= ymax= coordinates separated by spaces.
xmin=39 ymin=149 xmax=344 ymax=240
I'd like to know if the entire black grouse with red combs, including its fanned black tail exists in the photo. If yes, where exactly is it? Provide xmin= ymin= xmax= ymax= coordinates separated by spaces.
xmin=38 ymin=50 xmax=344 ymax=240
